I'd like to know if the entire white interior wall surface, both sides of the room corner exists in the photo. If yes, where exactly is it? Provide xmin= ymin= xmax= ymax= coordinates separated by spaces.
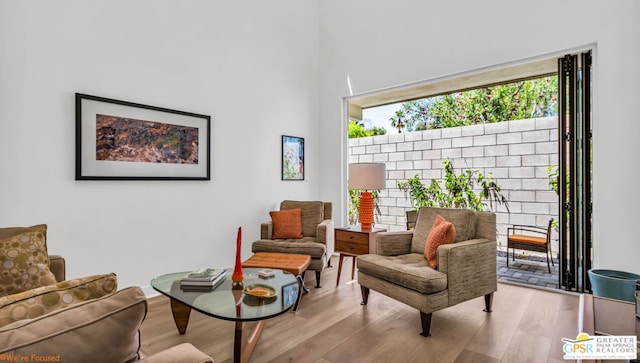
xmin=0 ymin=0 xmax=640 ymax=292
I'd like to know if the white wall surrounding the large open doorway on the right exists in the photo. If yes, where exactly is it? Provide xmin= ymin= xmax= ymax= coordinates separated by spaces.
xmin=320 ymin=0 xmax=640 ymax=273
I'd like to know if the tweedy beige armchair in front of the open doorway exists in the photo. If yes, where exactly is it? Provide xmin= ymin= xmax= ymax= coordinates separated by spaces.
xmin=357 ymin=207 xmax=498 ymax=336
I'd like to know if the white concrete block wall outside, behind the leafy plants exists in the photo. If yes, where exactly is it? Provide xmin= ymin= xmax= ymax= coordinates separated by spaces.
xmin=348 ymin=116 xmax=559 ymax=251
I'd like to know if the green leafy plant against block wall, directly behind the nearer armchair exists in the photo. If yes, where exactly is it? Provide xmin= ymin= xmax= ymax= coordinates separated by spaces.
xmin=397 ymin=159 xmax=509 ymax=212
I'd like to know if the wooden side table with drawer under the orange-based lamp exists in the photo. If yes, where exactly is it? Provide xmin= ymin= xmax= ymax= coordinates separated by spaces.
xmin=335 ymin=226 xmax=387 ymax=286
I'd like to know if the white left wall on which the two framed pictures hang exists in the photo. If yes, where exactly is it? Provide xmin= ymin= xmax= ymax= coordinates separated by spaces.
xmin=0 ymin=0 xmax=321 ymax=291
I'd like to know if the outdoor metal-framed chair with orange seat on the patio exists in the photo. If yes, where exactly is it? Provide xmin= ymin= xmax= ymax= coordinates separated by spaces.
xmin=507 ymin=218 xmax=555 ymax=273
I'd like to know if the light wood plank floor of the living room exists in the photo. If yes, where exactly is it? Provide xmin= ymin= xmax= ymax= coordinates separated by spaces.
xmin=142 ymin=258 xmax=579 ymax=363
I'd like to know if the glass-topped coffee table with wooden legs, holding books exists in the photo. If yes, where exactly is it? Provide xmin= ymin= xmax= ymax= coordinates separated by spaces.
xmin=151 ymin=268 xmax=300 ymax=362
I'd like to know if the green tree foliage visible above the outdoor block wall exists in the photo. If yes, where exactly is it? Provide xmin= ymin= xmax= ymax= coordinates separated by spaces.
xmin=389 ymin=76 xmax=558 ymax=132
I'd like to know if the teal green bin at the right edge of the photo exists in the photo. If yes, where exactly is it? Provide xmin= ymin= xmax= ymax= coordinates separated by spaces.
xmin=588 ymin=270 xmax=640 ymax=302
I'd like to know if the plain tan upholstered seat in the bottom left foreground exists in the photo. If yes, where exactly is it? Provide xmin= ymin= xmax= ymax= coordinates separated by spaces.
xmin=0 ymin=287 xmax=213 ymax=363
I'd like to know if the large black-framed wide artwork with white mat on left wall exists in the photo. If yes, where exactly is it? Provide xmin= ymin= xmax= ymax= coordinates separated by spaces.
xmin=76 ymin=93 xmax=211 ymax=180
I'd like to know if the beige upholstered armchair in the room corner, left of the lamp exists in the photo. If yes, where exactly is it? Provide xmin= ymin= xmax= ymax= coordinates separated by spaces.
xmin=251 ymin=200 xmax=334 ymax=287
